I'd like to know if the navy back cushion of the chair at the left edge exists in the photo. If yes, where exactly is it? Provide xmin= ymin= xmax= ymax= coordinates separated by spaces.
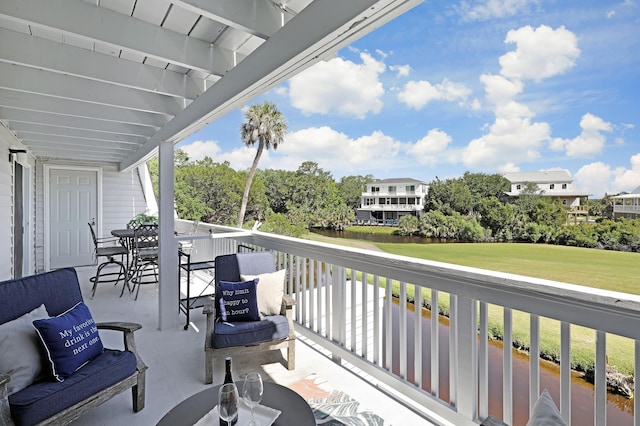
xmin=0 ymin=268 xmax=83 ymax=323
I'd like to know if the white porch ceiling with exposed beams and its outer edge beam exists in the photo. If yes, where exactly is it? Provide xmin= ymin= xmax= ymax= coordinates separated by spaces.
xmin=0 ymin=0 xmax=422 ymax=170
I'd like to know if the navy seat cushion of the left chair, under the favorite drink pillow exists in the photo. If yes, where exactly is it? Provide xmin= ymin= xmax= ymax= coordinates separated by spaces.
xmin=9 ymin=349 xmax=137 ymax=426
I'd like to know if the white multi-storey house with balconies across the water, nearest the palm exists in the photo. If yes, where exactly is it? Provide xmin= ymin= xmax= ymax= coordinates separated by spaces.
xmin=356 ymin=178 xmax=429 ymax=226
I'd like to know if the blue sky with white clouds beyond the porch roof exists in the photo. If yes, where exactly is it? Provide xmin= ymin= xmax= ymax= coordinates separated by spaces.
xmin=178 ymin=0 xmax=640 ymax=198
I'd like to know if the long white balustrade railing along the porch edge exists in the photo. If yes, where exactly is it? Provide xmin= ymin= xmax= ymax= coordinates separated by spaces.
xmin=178 ymin=224 xmax=640 ymax=425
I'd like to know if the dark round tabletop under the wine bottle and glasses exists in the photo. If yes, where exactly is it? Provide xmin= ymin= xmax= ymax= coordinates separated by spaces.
xmin=157 ymin=382 xmax=316 ymax=426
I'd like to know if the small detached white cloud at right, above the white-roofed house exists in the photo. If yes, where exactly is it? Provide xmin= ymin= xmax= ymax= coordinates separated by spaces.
xmin=550 ymin=113 xmax=613 ymax=157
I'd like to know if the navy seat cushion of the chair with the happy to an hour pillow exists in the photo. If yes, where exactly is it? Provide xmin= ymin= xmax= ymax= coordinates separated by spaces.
xmin=213 ymin=315 xmax=289 ymax=349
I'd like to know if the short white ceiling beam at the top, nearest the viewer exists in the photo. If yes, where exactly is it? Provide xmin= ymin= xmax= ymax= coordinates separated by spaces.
xmin=172 ymin=0 xmax=282 ymax=40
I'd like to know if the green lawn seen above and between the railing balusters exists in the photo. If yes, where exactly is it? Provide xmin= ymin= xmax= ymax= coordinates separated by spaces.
xmin=302 ymin=238 xmax=640 ymax=375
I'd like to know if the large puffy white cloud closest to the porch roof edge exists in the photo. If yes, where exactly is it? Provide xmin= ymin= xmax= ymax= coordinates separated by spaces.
xmin=289 ymin=53 xmax=386 ymax=119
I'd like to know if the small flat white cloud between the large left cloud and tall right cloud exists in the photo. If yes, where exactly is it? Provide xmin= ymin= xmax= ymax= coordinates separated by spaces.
xmin=398 ymin=78 xmax=471 ymax=109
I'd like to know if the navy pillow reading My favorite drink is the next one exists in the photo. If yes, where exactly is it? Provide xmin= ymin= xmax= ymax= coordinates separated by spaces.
xmin=33 ymin=302 xmax=104 ymax=382
